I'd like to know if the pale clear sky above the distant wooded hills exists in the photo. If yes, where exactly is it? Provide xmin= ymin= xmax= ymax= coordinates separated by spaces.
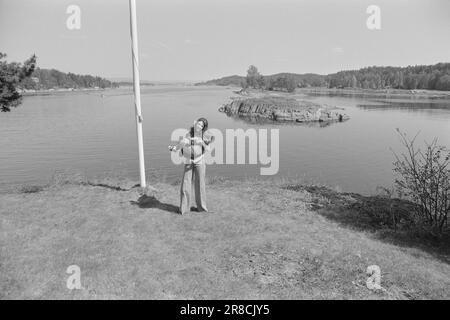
xmin=0 ymin=0 xmax=450 ymax=81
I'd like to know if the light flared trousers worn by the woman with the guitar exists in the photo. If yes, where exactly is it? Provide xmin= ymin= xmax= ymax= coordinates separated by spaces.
xmin=180 ymin=161 xmax=208 ymax=214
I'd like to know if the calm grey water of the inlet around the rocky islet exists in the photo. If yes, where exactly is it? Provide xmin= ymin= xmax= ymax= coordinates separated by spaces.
xmin=0 ymin=86 xmax=450 ymax=193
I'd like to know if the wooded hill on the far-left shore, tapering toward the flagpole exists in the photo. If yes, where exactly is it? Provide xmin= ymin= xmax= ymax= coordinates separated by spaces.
xmin=20 ymin=68 xmax=119 ymax=90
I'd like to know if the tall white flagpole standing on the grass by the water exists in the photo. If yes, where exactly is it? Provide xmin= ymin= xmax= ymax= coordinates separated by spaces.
xmin=129 ymin=0 xmax=146 ymax=188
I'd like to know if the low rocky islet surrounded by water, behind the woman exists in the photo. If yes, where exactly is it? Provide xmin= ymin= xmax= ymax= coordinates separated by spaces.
xmin=219 ymin=96 xmax=349 ymax=122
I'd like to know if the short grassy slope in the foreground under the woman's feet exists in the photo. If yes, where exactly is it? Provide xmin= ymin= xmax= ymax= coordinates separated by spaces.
xmin=0 ymin=181 xmax=450 ymax=299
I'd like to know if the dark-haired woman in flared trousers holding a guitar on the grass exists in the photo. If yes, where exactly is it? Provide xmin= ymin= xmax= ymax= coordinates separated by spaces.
xmin=169 ymin=118 xmax=214 ymax=214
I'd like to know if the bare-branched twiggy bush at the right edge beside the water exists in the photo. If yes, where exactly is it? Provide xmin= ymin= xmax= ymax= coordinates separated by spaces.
xmin=394 ymin=129 xmax=450 ymax=235
